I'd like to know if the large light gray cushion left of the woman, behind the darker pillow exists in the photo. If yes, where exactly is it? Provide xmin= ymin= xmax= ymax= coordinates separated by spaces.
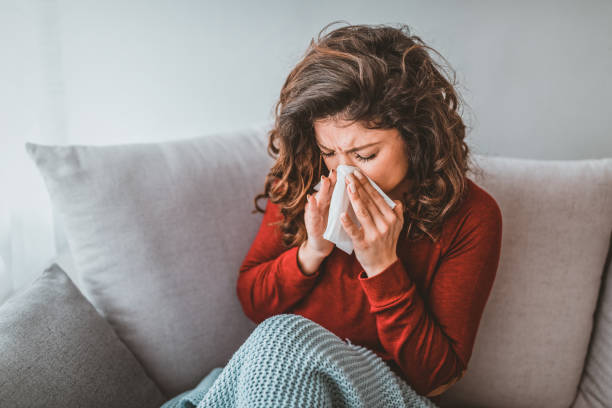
xmin=26 ymin=125 xmax=272 ymax=396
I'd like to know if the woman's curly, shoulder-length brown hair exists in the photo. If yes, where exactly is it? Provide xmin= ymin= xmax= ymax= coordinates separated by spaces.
xmin=252 ymin=20 xmax=480 ymax=247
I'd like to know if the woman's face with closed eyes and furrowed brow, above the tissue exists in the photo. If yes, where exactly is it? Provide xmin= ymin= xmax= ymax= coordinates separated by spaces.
xmin=314 ymin=119 xmax=409 ymax=199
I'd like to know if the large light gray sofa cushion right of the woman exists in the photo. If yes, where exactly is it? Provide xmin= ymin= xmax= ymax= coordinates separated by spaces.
xmin=430 ymin=157 xmax=612 ymax=407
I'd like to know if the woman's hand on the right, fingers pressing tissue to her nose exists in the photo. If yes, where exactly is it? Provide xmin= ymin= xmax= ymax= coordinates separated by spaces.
xmin=340 ymin=170 xmax=404 ymax=277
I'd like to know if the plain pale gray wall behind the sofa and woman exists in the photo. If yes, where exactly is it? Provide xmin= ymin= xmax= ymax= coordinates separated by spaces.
xmin=0 ymin=0 xmax=612 ymax=303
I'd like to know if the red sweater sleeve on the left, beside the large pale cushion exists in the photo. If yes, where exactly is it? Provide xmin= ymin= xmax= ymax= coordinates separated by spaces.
xmin=236 ymin=200 xmax=320 ymax=324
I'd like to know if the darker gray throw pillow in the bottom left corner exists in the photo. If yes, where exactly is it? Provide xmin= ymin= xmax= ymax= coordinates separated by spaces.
xmin=0 ymin=263 xmax=165 ymax=408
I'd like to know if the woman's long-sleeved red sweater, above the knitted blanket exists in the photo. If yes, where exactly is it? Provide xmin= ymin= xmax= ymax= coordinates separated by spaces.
xmin=236 ymin=179 xmax=502 ymax=395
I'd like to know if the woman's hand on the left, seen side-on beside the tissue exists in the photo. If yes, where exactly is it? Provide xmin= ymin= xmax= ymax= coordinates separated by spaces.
xmin=304 ymin=170 xmax=337 ymax=256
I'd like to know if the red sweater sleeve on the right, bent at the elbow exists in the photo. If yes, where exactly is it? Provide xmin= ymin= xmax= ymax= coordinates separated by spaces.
xmin=359 ymin=200 xmax=502 ymax=395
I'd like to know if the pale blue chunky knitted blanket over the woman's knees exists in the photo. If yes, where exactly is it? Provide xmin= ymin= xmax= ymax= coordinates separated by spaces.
xmin=161 ymin=314 xmax=437 ymax=408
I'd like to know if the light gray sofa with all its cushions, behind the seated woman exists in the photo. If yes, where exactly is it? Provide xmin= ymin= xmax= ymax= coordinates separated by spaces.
xmin=0 ymin=123 xmax=612 ymax=408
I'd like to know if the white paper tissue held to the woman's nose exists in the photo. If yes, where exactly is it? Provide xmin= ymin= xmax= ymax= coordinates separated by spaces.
xmin=314 ymin=164 xmax=396 ymax=255
